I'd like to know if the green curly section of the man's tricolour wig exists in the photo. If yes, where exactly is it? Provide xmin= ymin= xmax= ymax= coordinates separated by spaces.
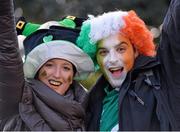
xmin=76 ymin=21 xmax=99 ymax=70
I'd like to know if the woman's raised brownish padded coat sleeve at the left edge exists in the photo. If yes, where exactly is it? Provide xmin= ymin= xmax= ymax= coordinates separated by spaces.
xmin=0 ymin=0 xmax=24 ymax=120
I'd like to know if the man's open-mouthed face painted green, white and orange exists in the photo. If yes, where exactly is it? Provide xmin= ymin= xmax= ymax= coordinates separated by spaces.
xmin=96 ymin=35 xmax=136 ymax=88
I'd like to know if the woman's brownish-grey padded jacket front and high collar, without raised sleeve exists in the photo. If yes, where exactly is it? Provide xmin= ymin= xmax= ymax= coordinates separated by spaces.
xmin=19 ymin=79 xmax=86 ymax=131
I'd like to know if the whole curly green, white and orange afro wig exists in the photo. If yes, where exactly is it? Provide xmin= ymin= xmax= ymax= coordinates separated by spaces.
xmin=77 ymin=11 xmax=156 ymax=69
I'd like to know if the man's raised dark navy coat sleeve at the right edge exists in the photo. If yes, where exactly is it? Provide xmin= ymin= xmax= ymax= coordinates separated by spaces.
xmin=158 ymin=0 xmax=180 ymax=130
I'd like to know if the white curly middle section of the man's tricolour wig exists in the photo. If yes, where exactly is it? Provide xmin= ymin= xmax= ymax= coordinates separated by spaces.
xmin=89 ymin=11 xmax=128 ymax=43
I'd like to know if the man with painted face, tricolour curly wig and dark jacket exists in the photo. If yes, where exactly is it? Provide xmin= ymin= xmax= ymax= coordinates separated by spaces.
xmin=77 ymin=0 xmax=180 ymax=131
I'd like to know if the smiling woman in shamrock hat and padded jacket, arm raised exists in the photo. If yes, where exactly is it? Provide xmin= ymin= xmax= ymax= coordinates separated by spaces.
xmin=0 ymin=0 xmax=94 ymax=131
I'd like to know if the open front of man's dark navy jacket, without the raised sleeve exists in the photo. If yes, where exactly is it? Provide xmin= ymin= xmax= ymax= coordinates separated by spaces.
xmin=86 ymin=56 xmax=174 ymax=131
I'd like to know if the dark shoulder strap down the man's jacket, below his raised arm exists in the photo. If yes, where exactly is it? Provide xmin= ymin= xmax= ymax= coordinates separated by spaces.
xmin=144 ymin=69 xmax=177 ymax=129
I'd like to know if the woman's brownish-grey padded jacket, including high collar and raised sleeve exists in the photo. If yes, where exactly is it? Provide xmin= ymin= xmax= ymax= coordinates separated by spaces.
xmin=0 ymin=0 xmax=86 ymax=131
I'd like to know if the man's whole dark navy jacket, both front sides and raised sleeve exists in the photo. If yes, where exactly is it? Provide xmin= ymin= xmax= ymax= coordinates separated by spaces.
xmin=86 ymin=0 xmax=180 ymax=131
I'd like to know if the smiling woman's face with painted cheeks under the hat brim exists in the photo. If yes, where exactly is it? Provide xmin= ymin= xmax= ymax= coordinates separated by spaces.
xmin=38 ymin=59 xmax=74 ymax=95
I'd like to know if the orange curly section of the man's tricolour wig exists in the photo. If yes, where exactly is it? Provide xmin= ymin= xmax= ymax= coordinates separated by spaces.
xmin=121 ymin=11 xmax=156 ymax=56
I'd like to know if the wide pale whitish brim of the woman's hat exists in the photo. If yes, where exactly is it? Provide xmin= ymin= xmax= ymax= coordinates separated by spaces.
xmin=24 ymin=40 xmax=94 ymax=80
